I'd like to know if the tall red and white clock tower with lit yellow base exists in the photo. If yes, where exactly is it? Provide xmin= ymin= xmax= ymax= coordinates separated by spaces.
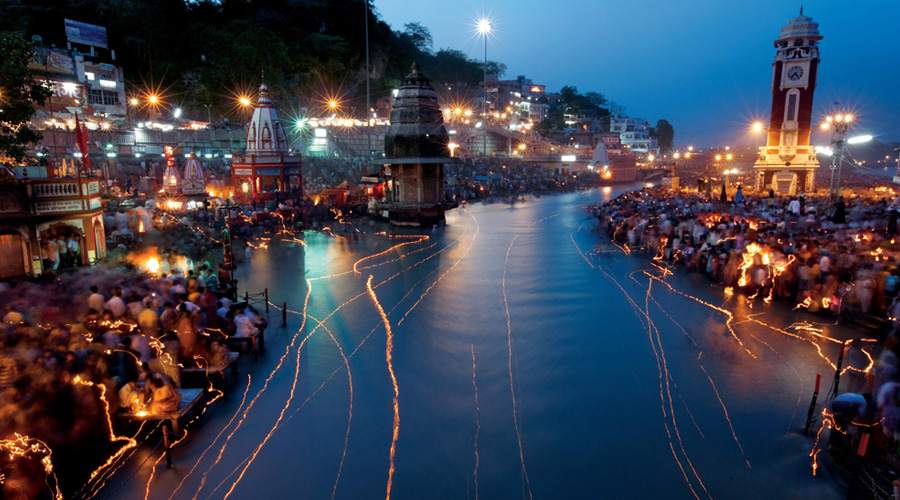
xmin=753 ymin=8 xmax=822 ymax=194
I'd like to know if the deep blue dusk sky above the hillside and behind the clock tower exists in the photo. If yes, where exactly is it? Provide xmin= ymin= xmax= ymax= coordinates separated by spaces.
xmin=374 ymin=0 xmax=900 ymax=147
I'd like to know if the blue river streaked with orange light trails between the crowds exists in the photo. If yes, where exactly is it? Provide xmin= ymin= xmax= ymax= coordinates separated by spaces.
xmin=99 ymin=188 xmax=860 ymax=499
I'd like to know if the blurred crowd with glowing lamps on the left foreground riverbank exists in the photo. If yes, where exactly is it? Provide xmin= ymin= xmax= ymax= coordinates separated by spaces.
xmin=0 ymin=254 xmax=265 ymax=498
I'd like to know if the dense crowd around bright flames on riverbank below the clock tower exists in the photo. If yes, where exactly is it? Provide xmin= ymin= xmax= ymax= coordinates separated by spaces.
xmin=596 ymin=188 xmax=900 ymax=317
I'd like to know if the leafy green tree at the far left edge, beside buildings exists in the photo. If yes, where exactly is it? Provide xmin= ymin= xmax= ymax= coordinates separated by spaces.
xmin=0 ymin=32 xmax=50 ymax=163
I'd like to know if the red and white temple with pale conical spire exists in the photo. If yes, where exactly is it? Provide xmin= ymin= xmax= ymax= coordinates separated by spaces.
xmin=231 ymin=84 xmax=303 ymax=201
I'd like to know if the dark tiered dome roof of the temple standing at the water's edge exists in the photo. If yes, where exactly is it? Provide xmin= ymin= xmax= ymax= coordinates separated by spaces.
xmin=384 ymin=62 xmax=450 ymax=163
